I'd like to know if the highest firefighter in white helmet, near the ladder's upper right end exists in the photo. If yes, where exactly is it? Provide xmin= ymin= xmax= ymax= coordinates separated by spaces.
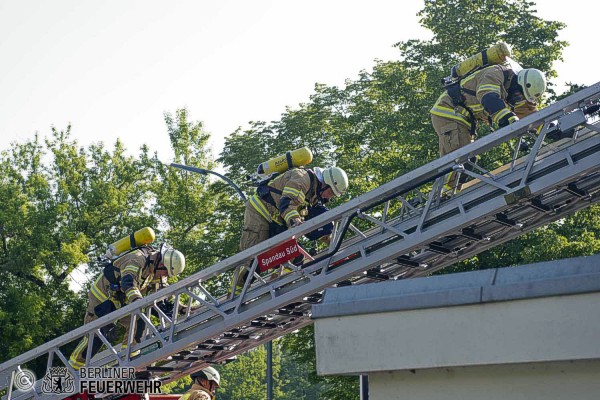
xmin=430 ymin=65 xmax=546 ymax=190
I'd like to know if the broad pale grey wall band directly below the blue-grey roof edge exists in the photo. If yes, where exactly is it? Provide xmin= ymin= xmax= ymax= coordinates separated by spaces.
xmin=315 ymin=293 xmax=600 ymax=376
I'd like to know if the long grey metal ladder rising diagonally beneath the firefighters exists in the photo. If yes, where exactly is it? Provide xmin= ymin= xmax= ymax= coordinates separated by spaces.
xmin=0 ymin=82 xmax=600 ymax=399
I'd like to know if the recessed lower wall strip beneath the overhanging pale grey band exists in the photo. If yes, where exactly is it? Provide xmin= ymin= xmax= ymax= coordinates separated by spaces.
xmin=369 ymin=361 xmax=600 ymax=400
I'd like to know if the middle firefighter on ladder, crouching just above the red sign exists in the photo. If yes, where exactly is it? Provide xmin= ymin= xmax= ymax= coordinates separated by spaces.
xmin=236 ymin=167 xmax=348 ymax=289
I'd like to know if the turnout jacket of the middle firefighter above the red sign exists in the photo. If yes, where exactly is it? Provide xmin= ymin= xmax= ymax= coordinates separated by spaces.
xmin=249 ymin=168 xmax=320 ymax=227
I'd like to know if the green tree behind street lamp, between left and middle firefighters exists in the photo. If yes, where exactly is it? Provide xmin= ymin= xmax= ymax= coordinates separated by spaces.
xmin=152 ymin=109 xmax=244 ymax=294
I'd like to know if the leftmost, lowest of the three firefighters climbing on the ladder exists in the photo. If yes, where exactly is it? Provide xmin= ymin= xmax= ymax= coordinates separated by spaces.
xmin=69 ymin=244 xmax=185 ymax=370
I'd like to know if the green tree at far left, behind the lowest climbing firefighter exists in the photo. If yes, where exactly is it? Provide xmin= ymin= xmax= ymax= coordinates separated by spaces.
xmin=0 ymin=127 xmax=155 ymax=368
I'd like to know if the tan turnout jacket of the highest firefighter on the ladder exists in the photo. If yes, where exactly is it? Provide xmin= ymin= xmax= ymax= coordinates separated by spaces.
xmin=430 ymin=65 xmax=537 ymax=128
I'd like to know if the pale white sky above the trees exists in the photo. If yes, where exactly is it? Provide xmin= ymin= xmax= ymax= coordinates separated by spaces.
xmin=0 ymin=0 xmax=600 ymax=166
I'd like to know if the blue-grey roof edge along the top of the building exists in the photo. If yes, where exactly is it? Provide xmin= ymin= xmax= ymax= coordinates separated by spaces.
xmin=312 ymin=254 xmax=600 ymax=319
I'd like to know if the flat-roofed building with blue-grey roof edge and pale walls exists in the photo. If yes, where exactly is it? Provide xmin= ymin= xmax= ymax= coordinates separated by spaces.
xmin=313 ymin=256 xmax=600 ymax=400
